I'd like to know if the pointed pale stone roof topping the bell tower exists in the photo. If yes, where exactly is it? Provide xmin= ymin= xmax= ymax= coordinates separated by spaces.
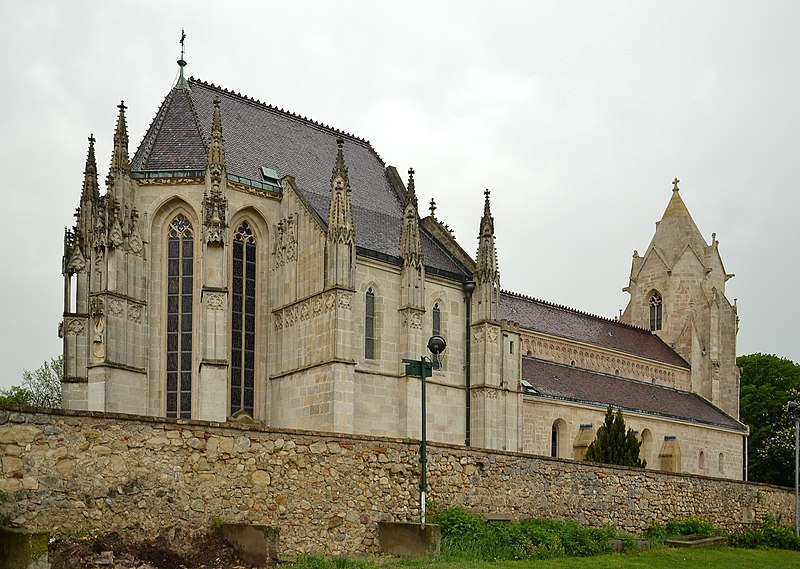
xmin=648 ymin=178 xmax=707 ymax=267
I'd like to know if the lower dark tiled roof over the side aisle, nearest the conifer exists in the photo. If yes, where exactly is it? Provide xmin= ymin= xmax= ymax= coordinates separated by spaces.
xmin=522 ymin=357 xmax=745 ymax=432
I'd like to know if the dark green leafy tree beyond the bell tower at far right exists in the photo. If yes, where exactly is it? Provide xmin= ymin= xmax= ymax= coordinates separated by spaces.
xmin=736 ymin=354 xmax=800 ymax=486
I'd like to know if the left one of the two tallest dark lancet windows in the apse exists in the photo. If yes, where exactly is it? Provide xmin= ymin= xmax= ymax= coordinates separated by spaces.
xmin=167 ymin=214 xmax=194 ymax=418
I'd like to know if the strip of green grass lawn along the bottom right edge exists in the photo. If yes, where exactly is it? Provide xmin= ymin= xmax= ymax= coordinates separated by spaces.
xmin=376 ymin=547 xmax=800 ymax=569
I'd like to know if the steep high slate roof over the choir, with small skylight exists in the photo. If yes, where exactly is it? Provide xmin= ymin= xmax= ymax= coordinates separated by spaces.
xmin=131 ymin=78 xmax=469 ymax=279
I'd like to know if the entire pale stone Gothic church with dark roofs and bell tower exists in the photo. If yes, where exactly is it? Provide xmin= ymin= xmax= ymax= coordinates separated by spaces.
xmin=60 ymin=55 xmax=747 ymax=479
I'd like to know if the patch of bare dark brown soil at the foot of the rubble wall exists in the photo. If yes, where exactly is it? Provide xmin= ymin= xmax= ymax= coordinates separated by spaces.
xmin=48 ymin=528 xmax=270 ymax=569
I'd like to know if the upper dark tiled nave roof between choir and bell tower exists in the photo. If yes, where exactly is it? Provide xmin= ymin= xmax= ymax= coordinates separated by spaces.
xmin=500 ymin=291 xmax=689 ymax=368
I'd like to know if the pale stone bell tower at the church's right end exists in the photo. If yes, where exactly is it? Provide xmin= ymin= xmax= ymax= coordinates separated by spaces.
xmin=620 ymin=178 xmax=739 ymax=419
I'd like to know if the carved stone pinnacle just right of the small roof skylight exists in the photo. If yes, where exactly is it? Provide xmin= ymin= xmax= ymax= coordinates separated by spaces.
xmin=325 ymin=138 xmax=356 ymax=290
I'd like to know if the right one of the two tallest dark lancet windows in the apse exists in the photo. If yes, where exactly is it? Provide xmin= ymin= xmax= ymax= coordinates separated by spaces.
xmin=231 ymin=221 xmax=256 ymax=417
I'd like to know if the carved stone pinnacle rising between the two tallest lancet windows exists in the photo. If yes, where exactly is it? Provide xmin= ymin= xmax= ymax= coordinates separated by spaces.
xmin=203 ymin=98 xmax=228 ymax=243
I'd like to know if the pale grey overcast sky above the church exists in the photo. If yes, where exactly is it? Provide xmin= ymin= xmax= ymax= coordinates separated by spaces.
xmin=0 ymin=0 xmax=800 ymax=387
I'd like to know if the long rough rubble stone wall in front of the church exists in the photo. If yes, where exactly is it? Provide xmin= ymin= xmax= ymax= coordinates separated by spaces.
xmin=0 ymin=407 xmax=794 ymax=554
